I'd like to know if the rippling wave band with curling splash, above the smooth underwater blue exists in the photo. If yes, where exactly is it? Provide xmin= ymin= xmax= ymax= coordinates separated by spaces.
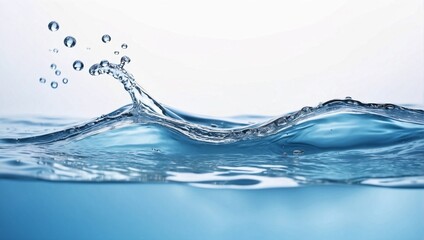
xmin=0 ymin=22 xmax=424 ymax=188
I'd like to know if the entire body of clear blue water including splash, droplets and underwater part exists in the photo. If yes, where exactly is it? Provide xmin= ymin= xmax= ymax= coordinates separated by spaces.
xmin=0 ymin=23 xmax=424 ymax=239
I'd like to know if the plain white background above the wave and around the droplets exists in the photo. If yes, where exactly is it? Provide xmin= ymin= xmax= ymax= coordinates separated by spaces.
xmin=0 ymin=0 xmax=424 ymax=117
